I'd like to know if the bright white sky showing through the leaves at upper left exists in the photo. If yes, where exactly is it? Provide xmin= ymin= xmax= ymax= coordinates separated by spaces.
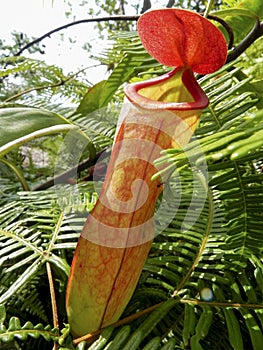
xmin=0 ymin=0 xmax=108 ymax=83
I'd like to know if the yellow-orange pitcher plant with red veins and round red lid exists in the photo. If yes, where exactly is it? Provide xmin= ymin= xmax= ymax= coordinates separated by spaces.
xmin=66 ymin=9 xmax=227 ymax=337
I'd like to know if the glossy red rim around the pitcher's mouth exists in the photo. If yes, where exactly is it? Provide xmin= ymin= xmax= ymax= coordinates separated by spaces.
xmin=124 ymin=67 xmax=209 ymax=111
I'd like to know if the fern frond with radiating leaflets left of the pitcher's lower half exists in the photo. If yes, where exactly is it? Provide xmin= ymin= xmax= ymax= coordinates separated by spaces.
xmin=0 ymin=183 xmax=97 ymax=321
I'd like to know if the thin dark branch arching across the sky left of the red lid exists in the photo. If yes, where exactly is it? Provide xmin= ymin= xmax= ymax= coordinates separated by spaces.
xmin=14 ymin=15 xmax=140 ymax=56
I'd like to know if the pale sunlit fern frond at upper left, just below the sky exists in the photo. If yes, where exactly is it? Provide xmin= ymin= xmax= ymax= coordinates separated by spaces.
xmin=0 ymin=57 xmax=88 ymax=107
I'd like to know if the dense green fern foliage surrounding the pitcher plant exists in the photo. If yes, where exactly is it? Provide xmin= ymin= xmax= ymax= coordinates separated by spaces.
xmin=0 ymin=0 xmax=263 ymax=350
